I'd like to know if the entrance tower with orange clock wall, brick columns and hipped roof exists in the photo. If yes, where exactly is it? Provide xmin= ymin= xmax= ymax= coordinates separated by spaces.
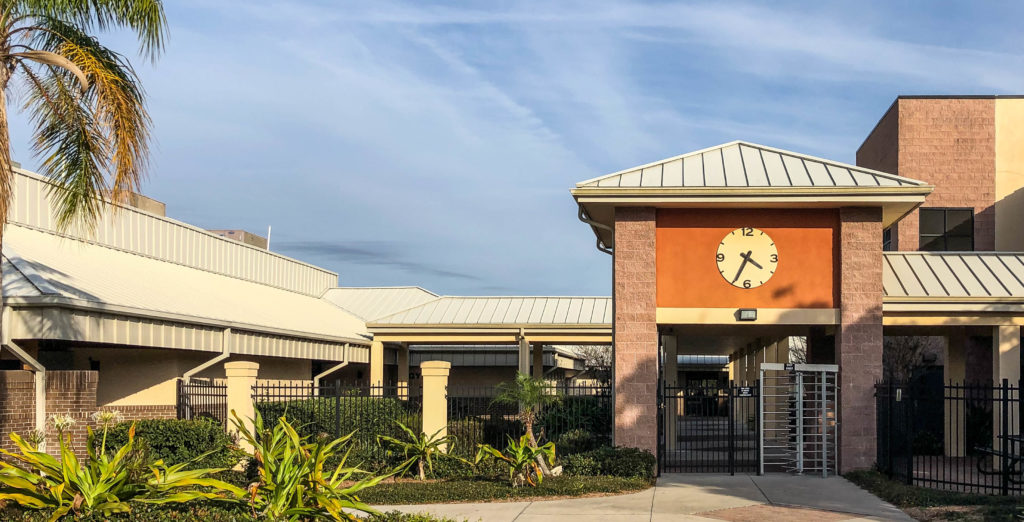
xmin=572 ymin=142 xmax=932 ymax=471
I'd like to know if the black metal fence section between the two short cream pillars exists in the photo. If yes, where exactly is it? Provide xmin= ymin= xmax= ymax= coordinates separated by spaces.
xmin=253 ymin=382 xmax=423 ymax=468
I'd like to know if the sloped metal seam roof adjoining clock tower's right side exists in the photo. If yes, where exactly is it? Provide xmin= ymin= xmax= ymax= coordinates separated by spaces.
xmin=882 ymin=252 xmax=1024 ymax=300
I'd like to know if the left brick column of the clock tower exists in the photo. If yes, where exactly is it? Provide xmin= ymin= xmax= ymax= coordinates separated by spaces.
xmin=613 ymin=207 xmax=658 ymax=454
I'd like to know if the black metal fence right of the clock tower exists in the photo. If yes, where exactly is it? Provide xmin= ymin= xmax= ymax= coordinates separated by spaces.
xmin=876 ymin=380 xmax=1024 ymax=495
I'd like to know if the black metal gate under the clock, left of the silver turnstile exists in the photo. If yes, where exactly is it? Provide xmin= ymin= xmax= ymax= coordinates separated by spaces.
xmin=658 ymin=382 xmax=760 ymax=473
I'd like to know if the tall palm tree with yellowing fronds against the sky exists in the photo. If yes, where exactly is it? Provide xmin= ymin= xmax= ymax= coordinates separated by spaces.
xmin=0 ymin=0 xmax=167 ymax=229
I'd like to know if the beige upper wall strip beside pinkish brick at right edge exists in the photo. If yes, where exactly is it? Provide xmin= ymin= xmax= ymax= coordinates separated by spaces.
xmin=995 ymin=98 xmax=1024 ymax=252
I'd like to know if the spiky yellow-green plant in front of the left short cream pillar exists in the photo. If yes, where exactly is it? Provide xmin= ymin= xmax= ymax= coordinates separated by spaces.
xmin=231 ymin=410 xmax=393 ymax=521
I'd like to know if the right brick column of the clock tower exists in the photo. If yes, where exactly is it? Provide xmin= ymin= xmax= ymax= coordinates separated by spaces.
xmin=836 ymin=208 xmax=883 ymax=473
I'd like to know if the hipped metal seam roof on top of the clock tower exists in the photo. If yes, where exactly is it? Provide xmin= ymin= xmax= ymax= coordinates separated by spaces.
xmin=577 ymin=141 xmax=929 ymax=188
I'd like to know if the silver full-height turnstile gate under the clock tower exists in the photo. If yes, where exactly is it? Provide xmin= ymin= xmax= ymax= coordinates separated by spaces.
xmin=758 ymin=362 xmax=839 ymax=477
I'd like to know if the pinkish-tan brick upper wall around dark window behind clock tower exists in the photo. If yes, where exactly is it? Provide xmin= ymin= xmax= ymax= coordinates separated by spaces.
xmin=857 ymin=96 xmax=996 ymax=251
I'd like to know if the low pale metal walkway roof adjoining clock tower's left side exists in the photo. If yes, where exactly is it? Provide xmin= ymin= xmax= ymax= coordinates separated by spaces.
xmin=371 ymin=296 xmax=612 ymax=327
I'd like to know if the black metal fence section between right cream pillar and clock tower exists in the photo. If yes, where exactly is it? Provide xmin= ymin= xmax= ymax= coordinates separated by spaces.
xmin=447 ymin=384 xmax=612 ymax=455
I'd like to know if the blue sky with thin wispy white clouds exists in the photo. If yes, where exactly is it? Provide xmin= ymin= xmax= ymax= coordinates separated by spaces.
xmin=11 ymin=0 xmax=1024 ymax=295
